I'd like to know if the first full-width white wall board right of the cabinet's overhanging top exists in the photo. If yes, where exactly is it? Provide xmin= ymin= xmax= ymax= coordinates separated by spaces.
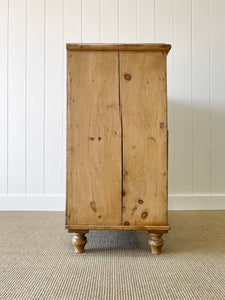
xmin=173 ymin=0 xmax=192 ymax=194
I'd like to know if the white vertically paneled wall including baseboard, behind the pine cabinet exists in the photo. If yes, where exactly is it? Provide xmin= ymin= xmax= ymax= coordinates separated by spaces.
xmin=0 ymin=0 xmax=225 ymax=210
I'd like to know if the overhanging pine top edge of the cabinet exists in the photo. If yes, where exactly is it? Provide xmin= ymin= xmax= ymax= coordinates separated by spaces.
xmin=66 ymin=44 xmax=171 ymax=53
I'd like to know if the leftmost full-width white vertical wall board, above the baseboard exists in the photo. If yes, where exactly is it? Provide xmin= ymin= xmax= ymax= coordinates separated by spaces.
xmin=8 ymin=0 xmax=26 ymax=194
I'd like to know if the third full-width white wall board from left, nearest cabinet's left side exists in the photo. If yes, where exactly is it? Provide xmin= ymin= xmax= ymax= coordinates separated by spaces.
xmin=45 ymin=0 xmax=63 ymax=194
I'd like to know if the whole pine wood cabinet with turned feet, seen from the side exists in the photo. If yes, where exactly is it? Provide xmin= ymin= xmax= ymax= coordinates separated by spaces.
xmin=66 ymin=44 xmax=171 ymax=254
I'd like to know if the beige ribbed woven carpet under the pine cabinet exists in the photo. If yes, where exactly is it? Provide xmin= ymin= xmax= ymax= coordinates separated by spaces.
xmin=0 ymin=211 xmax=225 ymax=300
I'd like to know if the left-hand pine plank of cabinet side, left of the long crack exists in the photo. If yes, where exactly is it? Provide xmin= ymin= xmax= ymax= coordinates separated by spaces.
xmin=66 ymin=51 xmax=122 ymax=225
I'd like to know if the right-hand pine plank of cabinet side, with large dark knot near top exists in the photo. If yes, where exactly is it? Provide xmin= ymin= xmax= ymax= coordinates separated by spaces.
xmin=120 ymin=51 xmax=168 ymax=226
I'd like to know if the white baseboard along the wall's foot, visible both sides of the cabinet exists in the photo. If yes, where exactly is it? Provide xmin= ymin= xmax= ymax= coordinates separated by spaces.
xmin=0 ymin=194 xmax=225 ymax=211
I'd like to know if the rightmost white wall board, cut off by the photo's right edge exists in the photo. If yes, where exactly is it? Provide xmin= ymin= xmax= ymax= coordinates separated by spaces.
xmin=211 ymin=0 xmax=225 ymax=193
